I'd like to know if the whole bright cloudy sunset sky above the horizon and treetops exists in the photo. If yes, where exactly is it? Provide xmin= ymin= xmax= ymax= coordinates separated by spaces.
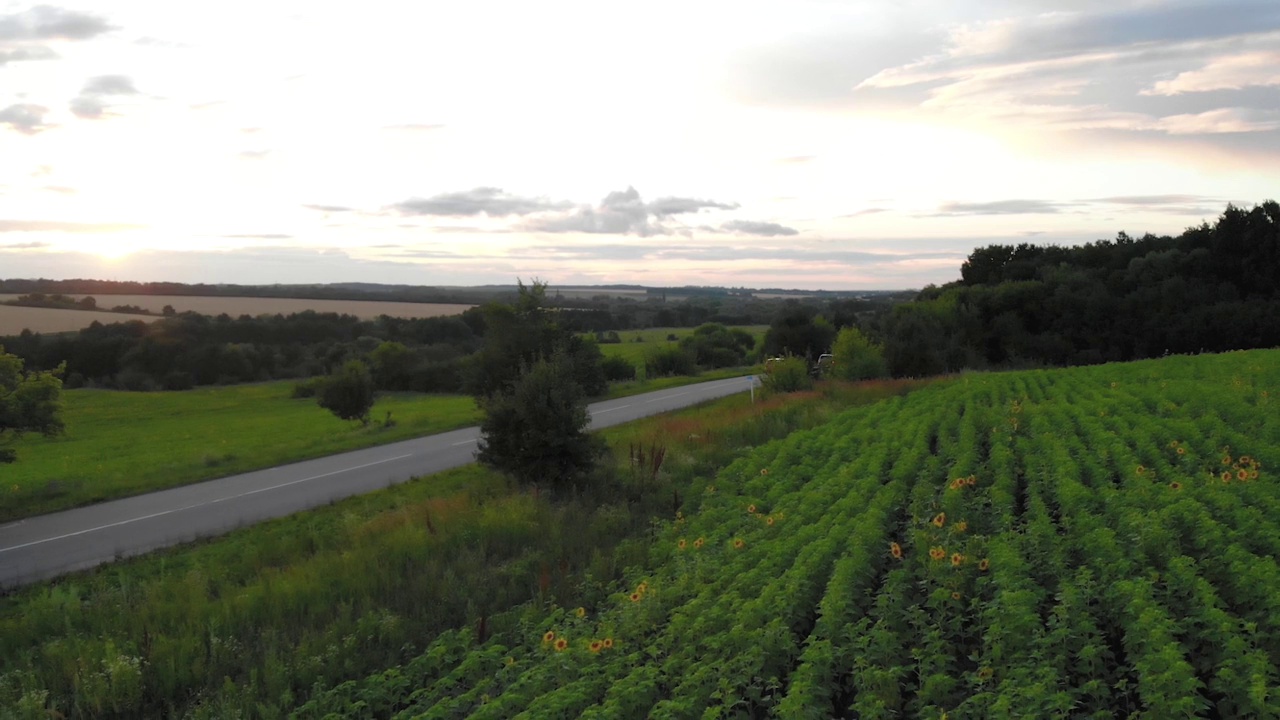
xmin=0 ymin=0 xmax=1280 ymax=290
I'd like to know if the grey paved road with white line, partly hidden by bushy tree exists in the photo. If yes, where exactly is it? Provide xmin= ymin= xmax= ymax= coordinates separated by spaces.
xmin=0 ymin=377 xmax=756 ymax=588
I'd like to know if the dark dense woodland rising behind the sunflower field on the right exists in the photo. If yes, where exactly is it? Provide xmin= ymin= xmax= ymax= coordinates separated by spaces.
xmin=883 ymin=201 xmax=1280 ymax=375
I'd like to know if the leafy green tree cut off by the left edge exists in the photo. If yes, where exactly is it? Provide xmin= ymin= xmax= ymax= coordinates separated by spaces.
xmin=0 ymin=346 xmax=64 ymax=462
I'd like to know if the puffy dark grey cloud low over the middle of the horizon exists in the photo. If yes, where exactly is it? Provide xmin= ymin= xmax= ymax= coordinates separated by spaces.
xmin=524 ymin=187 xmax=739 ymax=237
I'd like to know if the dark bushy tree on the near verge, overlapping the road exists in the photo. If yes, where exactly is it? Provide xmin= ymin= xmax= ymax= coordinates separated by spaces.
xmin=477 ymin=354 xmax=603 ymax=488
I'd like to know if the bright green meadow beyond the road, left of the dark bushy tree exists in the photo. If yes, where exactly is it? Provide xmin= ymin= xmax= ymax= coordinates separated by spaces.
xmin=0 ymin=382 xmax=480 ymax=523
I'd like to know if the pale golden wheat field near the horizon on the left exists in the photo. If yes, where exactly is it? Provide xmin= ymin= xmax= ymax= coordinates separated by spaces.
xmin=0 ymin=295 xmax=471 ymax=336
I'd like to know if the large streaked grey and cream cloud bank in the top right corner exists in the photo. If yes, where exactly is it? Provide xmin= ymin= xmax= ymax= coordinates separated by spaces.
xmin=854 ymin=0 xmax=1280 ymax=149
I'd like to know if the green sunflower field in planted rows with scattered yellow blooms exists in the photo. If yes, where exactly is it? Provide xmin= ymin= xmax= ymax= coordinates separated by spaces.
xmin=296 ymin=351 xmax=1280 ymax=720
